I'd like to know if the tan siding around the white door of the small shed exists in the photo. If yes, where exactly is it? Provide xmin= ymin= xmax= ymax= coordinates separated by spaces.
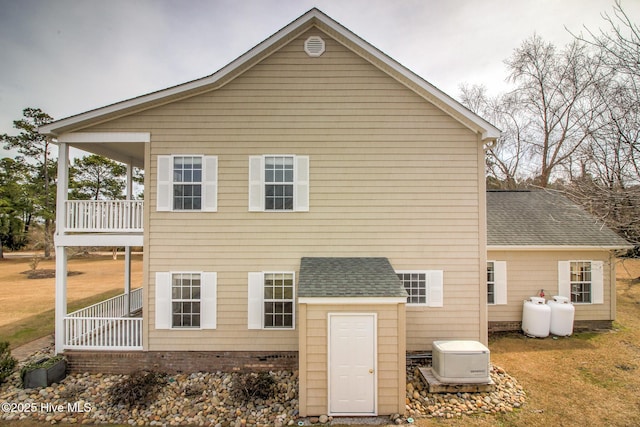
xmin=300 ymin=304 xmax=405 ymax=416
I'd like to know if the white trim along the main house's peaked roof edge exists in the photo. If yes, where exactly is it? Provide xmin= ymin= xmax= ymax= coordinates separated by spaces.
xmin=39 ymin=8 xmax=500 ymax=142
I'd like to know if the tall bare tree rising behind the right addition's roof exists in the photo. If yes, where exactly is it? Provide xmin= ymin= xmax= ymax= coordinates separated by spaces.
xmin=505 ymin=35 xmax=607 ymax=187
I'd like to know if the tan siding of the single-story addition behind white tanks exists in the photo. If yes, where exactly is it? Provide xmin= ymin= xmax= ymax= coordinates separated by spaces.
xmin=487 ymin=251 xmax=615 ymax=322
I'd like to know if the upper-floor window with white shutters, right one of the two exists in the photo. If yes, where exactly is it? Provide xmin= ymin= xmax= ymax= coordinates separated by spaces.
xmin=249 ymin=155 xmax=309 ymax=212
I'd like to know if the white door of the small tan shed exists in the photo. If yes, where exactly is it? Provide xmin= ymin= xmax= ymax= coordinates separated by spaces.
xmin=329 ymin=313 xmax=377 ymax=415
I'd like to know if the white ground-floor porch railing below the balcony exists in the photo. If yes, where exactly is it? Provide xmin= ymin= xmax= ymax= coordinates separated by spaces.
xmin=64 ymin=288 xmax=142 ymax=350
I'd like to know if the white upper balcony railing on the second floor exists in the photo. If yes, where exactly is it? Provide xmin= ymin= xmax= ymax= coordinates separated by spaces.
xmin=65 ymin=200 xmax=144 ymax=233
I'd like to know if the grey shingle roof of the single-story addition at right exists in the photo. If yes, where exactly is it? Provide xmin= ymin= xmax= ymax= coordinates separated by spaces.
xmin=487 ymin=190 xmax=631 ymax=249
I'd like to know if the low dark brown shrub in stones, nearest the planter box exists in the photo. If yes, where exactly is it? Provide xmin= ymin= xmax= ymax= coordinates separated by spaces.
xmin=108 ymin=370 xmax=165 ymax=408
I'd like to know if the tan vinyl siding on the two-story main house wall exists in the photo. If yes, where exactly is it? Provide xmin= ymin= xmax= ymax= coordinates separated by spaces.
xmin=79 ymin=30 xmax=486 ymax=351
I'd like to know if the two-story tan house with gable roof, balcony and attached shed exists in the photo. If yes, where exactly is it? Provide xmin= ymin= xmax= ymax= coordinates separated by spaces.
xmin=41 ymin=9 xmax=632 ymax=416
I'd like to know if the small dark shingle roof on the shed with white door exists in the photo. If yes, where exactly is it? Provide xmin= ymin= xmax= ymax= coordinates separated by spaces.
xmin=298 ymin=257 xmax=407 ymax=298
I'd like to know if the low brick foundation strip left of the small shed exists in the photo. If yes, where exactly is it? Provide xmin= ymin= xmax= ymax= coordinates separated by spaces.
xmin=64 ymin=351 xmax=298 ymax=374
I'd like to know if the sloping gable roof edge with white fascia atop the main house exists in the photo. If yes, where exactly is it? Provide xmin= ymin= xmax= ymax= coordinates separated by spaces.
xmin=40 ymin=8 xmax=500 ymax=140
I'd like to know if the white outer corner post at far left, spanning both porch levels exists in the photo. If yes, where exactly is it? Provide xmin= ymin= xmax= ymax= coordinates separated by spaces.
xmin=55 ymin=143 xmax=69 ymax=354
